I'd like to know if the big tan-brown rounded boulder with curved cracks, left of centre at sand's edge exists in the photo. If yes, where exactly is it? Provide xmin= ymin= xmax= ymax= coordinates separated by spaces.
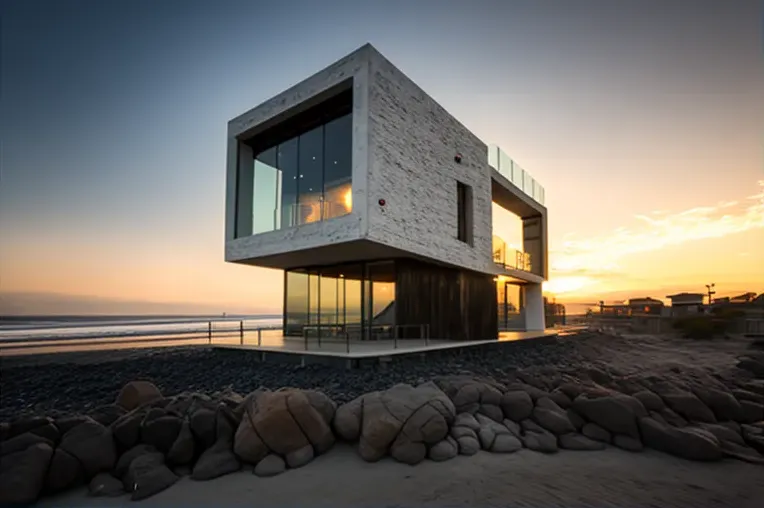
xmin=233 ymin=389 xmax=334 ymax=467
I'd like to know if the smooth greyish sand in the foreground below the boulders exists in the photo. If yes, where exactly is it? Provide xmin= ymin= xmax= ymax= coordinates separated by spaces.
xmin=39 ymin=445 xmax=764 ymax=508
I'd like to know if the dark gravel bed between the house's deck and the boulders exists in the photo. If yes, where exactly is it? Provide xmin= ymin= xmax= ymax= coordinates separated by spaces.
xmin=0 ymin=336 xmax=584 ymax=420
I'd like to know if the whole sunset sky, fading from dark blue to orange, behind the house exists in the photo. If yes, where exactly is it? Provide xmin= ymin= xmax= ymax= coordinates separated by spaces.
xmin=0 ymin=0 xmax=764 ymax=313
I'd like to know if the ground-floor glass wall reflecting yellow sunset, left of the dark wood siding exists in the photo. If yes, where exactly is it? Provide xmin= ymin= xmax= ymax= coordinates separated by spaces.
xmin=284 ymin=261 xmax=396 ymax=340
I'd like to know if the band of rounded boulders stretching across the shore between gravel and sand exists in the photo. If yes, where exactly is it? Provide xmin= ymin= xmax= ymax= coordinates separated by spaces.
xmin=0 ymin=332 xmax=764 ymax=505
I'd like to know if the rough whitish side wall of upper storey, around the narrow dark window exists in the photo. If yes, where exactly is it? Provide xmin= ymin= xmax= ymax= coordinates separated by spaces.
xmin=367 ymin=50 xmax=492 ymax=273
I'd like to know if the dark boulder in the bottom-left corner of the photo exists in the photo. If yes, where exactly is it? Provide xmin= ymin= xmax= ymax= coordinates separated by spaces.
xmin=0 ymin=442 xmax=53 ymax=506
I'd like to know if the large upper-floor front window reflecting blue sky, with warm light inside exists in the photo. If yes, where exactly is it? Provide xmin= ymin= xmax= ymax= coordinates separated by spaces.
xmin=237 ymin=113 xmax=353 ymax=237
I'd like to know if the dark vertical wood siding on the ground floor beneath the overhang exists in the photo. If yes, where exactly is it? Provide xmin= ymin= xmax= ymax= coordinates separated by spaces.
xmin=395 ymin=259 xmax=498 ymax=340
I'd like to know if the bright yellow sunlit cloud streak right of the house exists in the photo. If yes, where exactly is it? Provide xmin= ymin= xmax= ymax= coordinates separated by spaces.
xmin=548 ymin=180 xmax=764 ymax=292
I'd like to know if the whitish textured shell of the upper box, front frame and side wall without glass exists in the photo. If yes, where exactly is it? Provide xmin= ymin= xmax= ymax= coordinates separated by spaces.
xmin=225 ymin=45 xmax=494 ymax=273
